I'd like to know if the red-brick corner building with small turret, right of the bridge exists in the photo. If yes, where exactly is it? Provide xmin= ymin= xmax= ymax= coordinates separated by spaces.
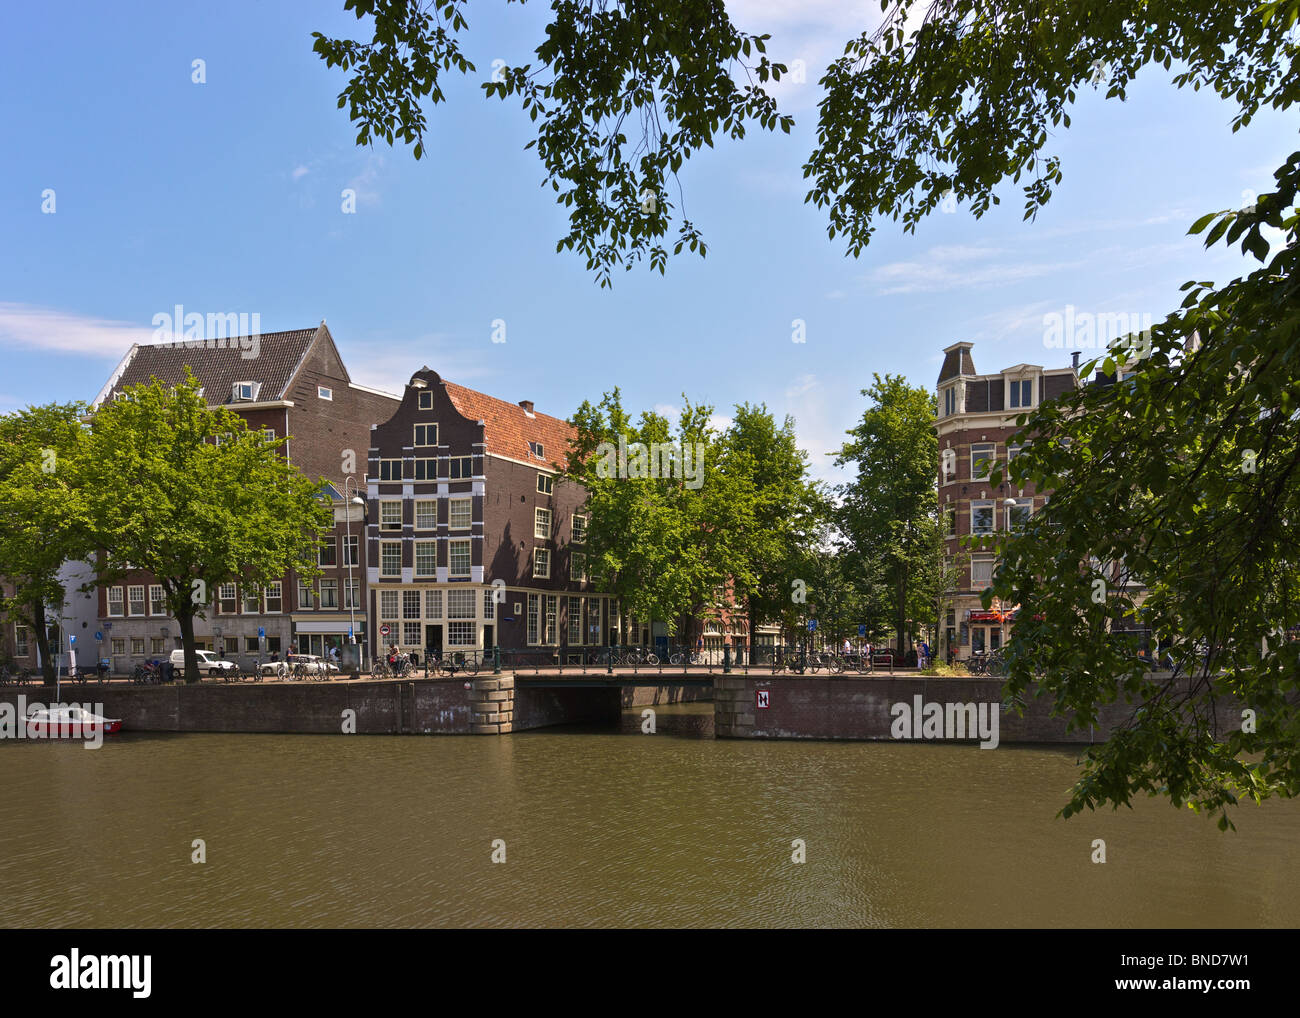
xmin=935 ymin=343 xmax=1079 ymax=659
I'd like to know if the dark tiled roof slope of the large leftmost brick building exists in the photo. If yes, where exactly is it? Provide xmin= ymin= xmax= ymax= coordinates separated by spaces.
xmin=96 ymin=326 xmax=321 ymax=404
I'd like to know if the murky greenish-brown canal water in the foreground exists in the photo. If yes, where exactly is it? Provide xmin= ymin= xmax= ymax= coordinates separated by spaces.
xmin=0 ymin=703 xmax=1300 ymax=927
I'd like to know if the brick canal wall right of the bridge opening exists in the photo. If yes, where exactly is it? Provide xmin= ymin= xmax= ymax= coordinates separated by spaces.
xmin=714 ymin=675 xmax=1242 ymax=744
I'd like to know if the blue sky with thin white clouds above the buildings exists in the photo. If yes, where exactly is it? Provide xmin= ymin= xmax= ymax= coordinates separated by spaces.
xmin=0 ymin=0 xmax=1296 ymax=478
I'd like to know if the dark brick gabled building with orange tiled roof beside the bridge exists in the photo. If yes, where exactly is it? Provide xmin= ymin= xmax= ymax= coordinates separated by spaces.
xmin=367 ymin=368 xmax=626 ymax=659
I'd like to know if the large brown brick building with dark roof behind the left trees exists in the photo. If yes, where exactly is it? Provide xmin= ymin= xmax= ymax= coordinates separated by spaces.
xmin=92 ymin=321 xmax=398 ymax=672
